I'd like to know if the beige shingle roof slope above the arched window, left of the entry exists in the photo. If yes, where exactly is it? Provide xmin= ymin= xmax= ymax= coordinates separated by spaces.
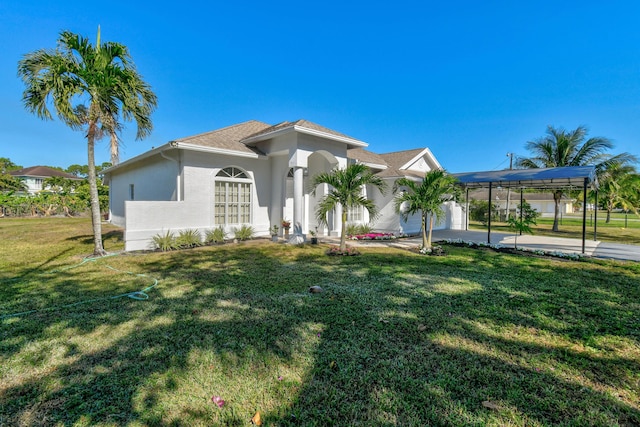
xmin=175 ymin=120 xmax=271 ymax=153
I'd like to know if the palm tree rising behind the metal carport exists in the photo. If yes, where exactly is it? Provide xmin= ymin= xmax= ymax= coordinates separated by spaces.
xmin=516 ymin=126 xmax=613 ymax=231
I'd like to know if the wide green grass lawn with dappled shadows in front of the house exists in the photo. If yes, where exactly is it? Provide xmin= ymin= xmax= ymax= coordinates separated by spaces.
xmin=0 ymin=218 xmax=640 ymax=426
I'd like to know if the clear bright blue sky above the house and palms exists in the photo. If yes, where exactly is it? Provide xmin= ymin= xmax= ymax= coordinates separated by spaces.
xmin=0 ymin=0 xmax=640 ymax=172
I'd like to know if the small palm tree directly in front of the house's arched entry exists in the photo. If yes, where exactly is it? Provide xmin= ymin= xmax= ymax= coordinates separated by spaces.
xmin=311 ymin=163 xmax=387 ymax=251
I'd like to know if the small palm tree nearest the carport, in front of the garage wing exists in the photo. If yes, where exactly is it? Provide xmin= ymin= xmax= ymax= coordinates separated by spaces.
xmin=393 ymin=169 xmax=456 ymax=249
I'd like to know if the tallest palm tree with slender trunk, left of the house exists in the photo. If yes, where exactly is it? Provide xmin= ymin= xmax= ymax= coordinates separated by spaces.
xmin=18 ymin=28 xmax=157 ymax=256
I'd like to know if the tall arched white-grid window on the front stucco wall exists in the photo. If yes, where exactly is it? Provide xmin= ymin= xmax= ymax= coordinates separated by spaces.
xmin=214 ymin=166 xmax=251 ymax=225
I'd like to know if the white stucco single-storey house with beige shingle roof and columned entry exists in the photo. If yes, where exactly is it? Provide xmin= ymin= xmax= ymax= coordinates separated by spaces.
xmin=103 ymin=120 xmax=463 ymax=250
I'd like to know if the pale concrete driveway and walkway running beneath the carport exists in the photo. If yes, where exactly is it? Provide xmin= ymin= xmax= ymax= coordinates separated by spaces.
xmin=330 ymin=230 xmax=640 ymax=262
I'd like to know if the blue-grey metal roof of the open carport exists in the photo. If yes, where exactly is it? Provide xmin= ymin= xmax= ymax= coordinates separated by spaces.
xmin=452 ymin=166 xmax=598 ymax=189
